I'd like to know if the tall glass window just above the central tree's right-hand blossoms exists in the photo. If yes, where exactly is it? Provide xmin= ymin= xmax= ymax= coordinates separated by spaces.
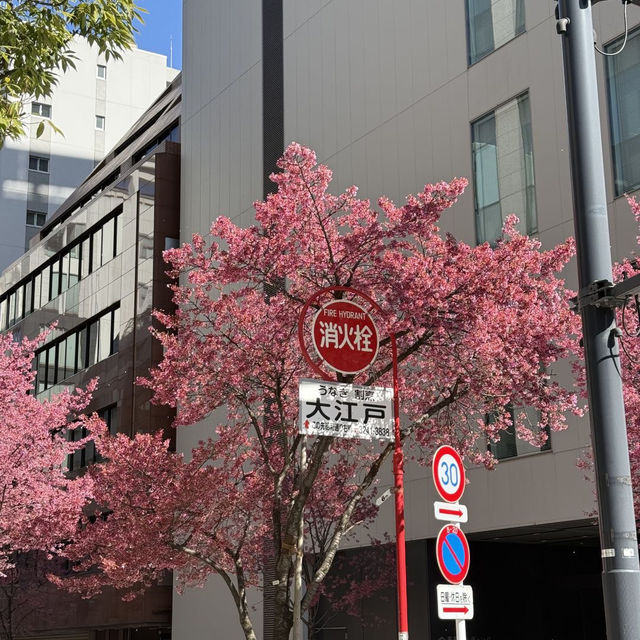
xmin=471 ymin=95 xmax=538 ymax=243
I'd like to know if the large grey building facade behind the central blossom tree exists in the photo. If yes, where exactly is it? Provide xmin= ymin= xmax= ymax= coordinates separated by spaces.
xmin=178 ymin=0 xmax=640 ymax=640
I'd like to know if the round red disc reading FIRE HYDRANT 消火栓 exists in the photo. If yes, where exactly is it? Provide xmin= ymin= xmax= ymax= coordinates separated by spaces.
xmin=311 ymin=300 xmax=378 ymax=374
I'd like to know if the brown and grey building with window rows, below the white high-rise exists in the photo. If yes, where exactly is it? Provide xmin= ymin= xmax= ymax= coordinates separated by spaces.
xmin=0 ymin=76 xmax=181 ymax=640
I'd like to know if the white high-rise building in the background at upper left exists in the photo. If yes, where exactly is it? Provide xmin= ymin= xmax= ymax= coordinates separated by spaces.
xmin=0 ymin=38 xmax=178 ymax=269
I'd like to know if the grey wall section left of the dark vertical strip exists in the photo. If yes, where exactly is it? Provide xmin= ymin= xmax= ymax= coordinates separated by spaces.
xmin=172 ymin=0 xmax=262 ymax=640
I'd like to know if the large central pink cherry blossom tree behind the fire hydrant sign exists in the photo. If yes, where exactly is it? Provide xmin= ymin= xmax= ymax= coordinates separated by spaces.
xmin=57 ymin=144 xmax=581 ymax=640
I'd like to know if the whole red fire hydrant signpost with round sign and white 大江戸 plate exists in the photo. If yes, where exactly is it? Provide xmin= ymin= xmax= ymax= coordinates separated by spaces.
xmin=298 ymin=287 xmax=409 ymax=640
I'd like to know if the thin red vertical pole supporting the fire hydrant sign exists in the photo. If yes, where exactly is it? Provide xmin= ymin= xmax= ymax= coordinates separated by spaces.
xmin=391 ymin=333 xmax=409 ymax=640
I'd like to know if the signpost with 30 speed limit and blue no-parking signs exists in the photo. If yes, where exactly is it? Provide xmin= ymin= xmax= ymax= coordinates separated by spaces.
xmin=431 ymin=445 xmax=473 ymax=640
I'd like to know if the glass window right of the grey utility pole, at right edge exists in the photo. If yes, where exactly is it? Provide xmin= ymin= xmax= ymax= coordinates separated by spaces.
xmin=606 ymin=30 xmax=640 ymax=196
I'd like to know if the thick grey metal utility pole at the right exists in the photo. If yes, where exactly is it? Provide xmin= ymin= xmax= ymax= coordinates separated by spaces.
xmin=557 ymin=0 xmax=640 ymax=640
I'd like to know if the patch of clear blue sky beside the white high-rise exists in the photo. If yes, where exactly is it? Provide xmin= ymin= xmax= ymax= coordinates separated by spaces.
xmin=136 ymin=0 xmax=182 ymax=69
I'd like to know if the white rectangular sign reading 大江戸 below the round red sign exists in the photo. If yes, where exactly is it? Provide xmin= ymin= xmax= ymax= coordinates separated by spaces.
xmin=298 ymin=379 xmax=394 ymax=440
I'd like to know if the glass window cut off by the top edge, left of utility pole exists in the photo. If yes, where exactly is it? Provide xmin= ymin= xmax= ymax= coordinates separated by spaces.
xmin=467 ymin=0 xmax=524 ymax=64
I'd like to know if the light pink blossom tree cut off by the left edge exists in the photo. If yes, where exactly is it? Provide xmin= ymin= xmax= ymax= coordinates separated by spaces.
xmin=0 ymin=334 xmax=95 ymax=575
